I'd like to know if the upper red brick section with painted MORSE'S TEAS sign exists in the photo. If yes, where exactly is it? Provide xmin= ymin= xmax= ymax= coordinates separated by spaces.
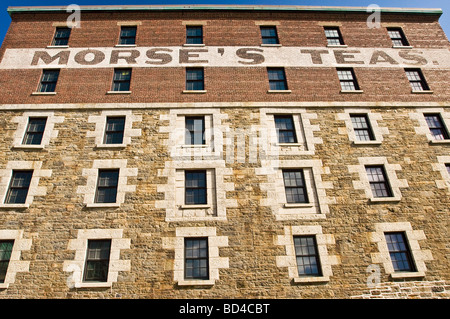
xmin=0 ymin=6 xmax=450 ymax=104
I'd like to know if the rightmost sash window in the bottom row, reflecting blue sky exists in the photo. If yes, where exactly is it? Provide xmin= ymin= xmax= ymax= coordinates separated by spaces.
xmin=384 ymin=232 xmax=416 ymax=272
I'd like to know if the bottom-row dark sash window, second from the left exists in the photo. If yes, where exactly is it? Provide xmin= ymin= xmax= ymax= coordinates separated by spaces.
xmin=84 ymin=239 xmax=111 ymax=282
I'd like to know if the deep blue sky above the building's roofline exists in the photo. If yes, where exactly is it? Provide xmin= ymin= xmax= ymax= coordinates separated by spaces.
xmin=0 ymin=0 xmax=450 ymax=42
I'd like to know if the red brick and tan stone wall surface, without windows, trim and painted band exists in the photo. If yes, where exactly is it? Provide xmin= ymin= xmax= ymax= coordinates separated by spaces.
xmin=0 ymin=5 xmax=450 ymax=298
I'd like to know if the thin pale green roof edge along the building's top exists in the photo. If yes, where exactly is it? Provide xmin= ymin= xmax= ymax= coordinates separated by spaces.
xmin=7 ymin=5 xmax=443 ymax=15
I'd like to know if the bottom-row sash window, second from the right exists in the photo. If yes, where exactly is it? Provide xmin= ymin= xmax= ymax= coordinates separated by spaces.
xmin=294 ymin=236 xmax=322 ymax=276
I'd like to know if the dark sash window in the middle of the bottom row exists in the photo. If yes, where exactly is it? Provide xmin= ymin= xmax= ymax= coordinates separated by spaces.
xmin=184 ymin=238 xmax=209 ymax=280
